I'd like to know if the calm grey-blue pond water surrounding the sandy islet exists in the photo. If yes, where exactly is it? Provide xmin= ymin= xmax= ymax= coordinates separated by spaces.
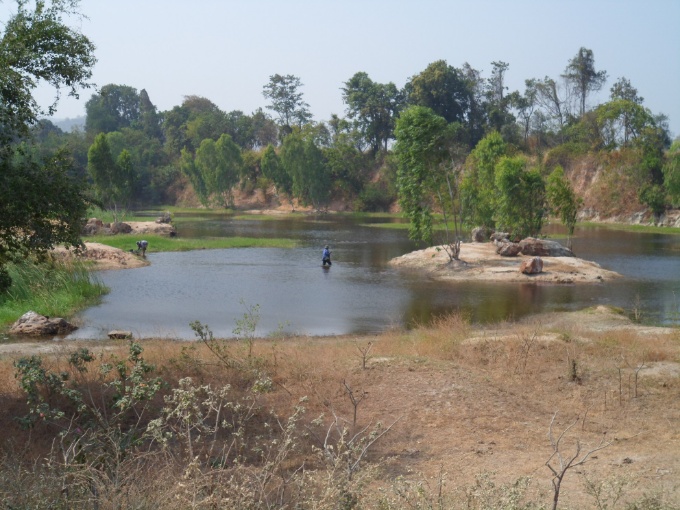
xmin=68 ymin=215 xmax=680 ymax=339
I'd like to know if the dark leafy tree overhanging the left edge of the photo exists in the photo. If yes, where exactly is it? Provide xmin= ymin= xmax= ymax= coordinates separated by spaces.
xmin=0 ymin=0 xmax=96 ymax=282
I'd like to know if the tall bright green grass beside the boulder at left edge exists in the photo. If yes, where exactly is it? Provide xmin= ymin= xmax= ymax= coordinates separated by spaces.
xmin=0 ymin=261 xmax=108 ymax=325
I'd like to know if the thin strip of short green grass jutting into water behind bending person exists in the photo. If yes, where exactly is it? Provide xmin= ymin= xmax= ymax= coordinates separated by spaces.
xmin=83 ymin=234 xmax=297 ymax=253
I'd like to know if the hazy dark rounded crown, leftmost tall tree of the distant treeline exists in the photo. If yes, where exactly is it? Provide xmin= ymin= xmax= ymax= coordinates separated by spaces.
xmin=85 ymin=84 xmax=140 ymax=136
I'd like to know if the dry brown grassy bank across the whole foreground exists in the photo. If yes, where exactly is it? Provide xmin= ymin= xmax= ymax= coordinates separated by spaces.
xmin=0 ymin=313 xmax=680 ymax=510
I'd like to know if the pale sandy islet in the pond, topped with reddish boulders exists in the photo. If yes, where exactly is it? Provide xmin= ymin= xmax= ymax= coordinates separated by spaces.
xmin=390 ymin=243 xmax=621 ymax=284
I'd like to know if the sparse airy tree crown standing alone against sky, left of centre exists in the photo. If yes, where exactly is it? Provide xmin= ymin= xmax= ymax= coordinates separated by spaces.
xmin=262 ymin=74 xmax=312 ymax=136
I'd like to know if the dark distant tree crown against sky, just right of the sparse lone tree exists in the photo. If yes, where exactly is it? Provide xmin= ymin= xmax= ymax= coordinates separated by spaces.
xmin=341 ymin=72 xmax=404 ymax=153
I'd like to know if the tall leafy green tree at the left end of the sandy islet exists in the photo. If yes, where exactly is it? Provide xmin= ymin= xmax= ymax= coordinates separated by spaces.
xmin=395 ymin=106 xmax=463 ymax=260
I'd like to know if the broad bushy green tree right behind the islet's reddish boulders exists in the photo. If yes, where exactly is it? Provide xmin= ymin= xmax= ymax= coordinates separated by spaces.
xmin=494 ymin=156 xmax=545 ymax=239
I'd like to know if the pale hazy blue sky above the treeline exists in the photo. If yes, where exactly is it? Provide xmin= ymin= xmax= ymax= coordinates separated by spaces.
xmin=13 ymin=0 xmax=680 ymax=136
